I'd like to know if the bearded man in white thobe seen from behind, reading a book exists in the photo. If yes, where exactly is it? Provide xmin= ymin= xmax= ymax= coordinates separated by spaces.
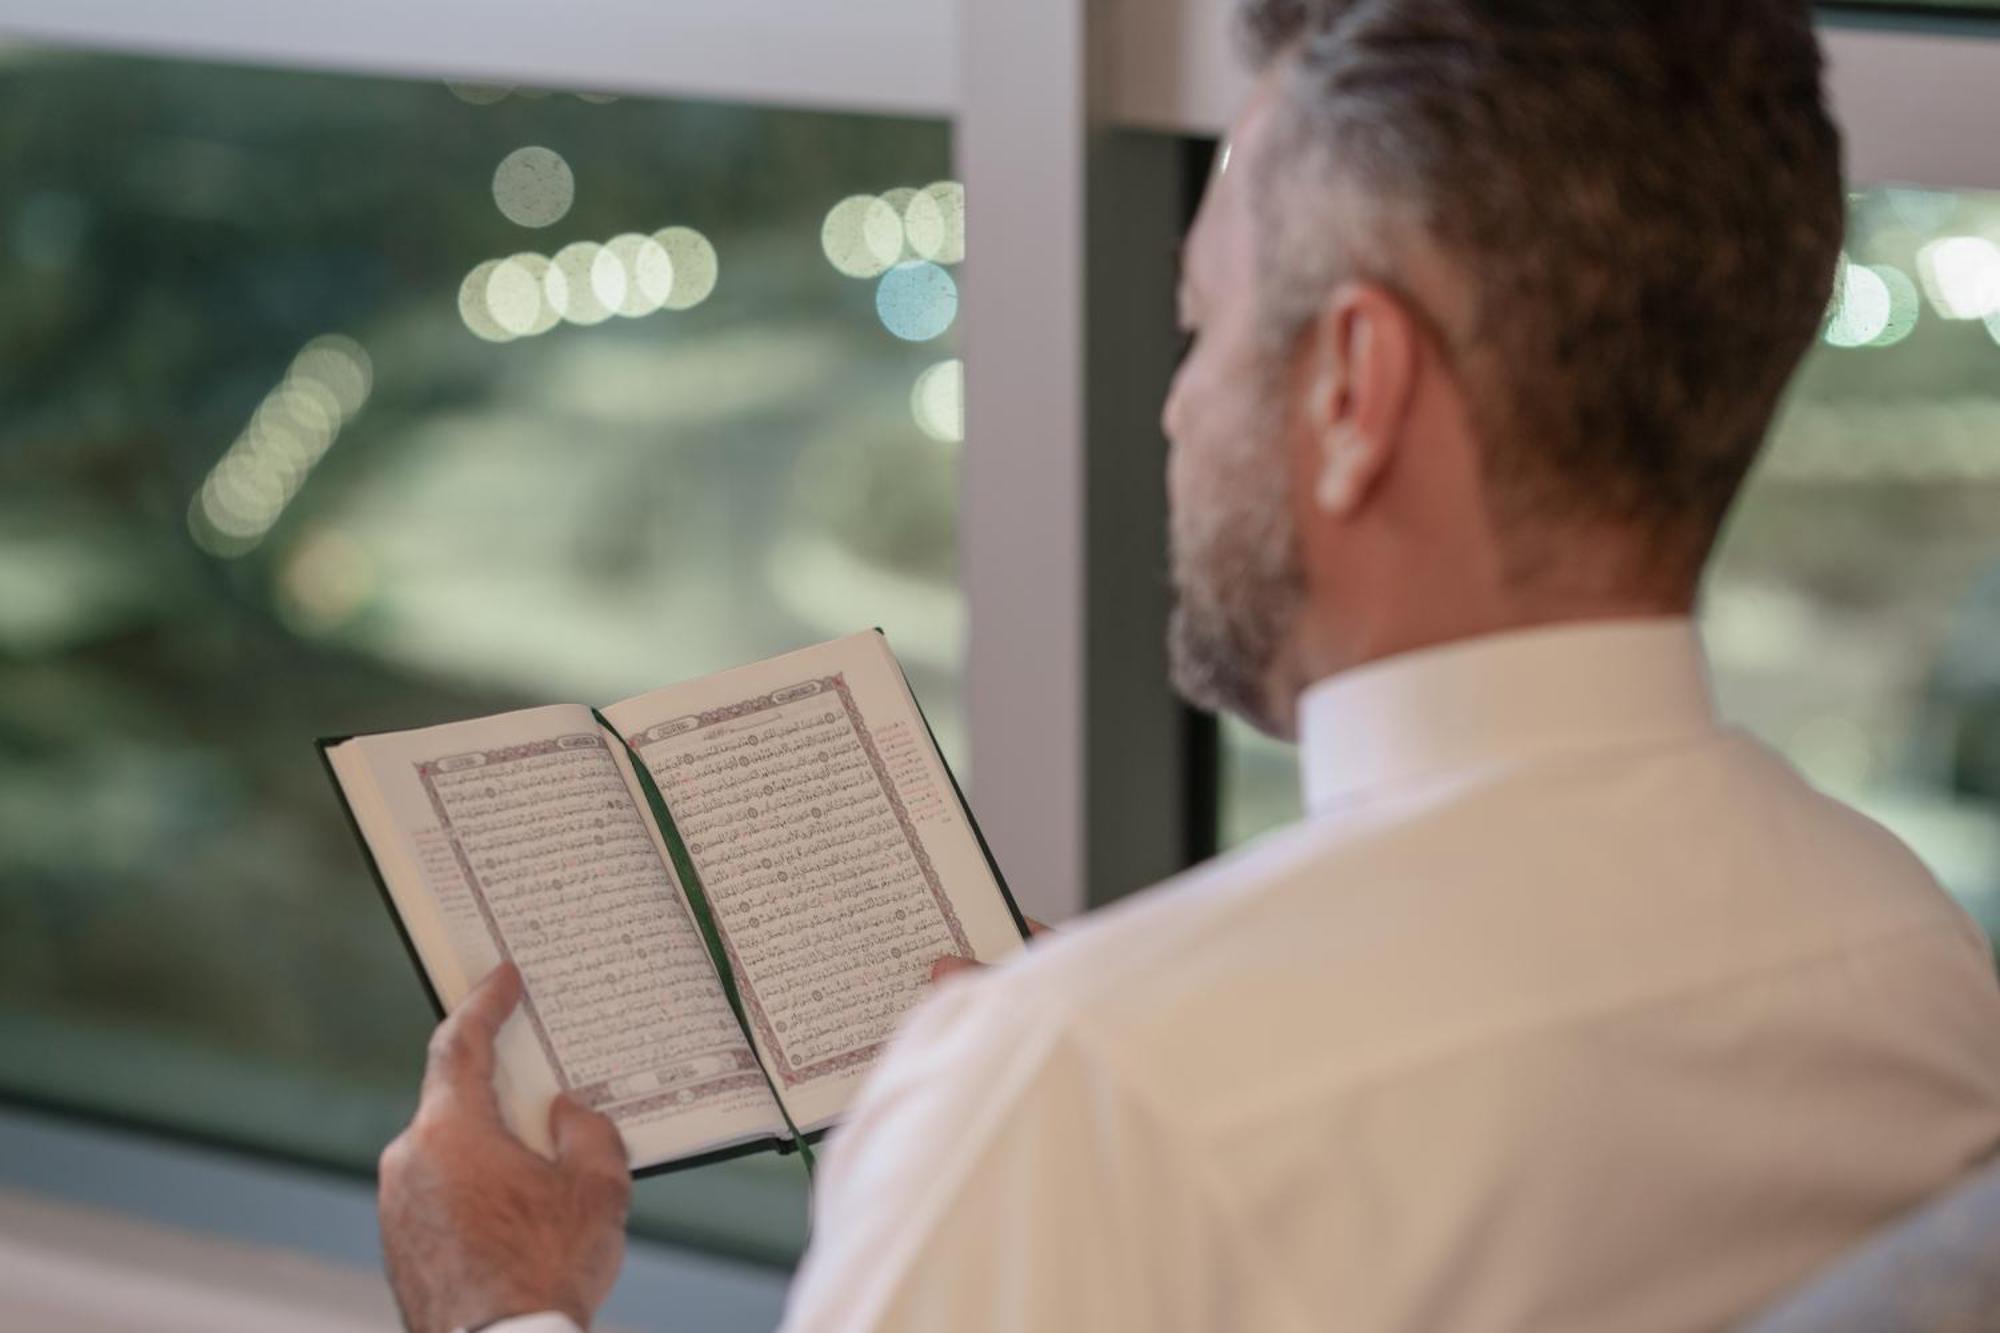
xmin=382 ymin=0 xmax=2000 ymax=1333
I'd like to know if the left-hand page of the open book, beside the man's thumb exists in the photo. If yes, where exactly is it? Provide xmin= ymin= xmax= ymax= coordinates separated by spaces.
xmin=334 ymin=707 xmax=782 ymax=1165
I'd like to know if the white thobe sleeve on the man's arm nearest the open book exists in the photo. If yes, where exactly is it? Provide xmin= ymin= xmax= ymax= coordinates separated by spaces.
xmin=784 ymin=975 xmax=1226 ymax=1333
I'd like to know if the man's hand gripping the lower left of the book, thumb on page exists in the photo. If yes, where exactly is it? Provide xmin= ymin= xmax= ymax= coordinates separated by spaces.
xmin=378 ymin=963 xmax=632 ymax=1333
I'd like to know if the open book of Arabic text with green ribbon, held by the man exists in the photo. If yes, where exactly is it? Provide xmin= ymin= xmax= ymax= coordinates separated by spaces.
xmin=320 ymin=632 xmax=1026 ymax=1171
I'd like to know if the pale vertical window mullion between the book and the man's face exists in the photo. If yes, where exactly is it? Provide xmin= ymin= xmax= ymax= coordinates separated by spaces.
xmin=956 ymin=0 xmax=1088 ymax=921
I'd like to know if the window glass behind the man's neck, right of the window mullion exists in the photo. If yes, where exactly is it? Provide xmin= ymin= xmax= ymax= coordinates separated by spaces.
xmin=1222 ymin=188 xmax=2000 ymax=956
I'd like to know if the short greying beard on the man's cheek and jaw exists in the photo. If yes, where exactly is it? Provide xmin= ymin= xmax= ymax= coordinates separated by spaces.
xmin=1168 ymin=392 xmax=1306 ymax=731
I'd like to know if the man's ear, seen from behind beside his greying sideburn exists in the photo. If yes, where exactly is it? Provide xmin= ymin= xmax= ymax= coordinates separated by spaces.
xmin=1306 ymin=282 xmax=1420 ymax=516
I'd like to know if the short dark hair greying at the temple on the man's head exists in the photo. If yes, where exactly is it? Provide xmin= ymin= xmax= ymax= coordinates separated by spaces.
xmin=1240 ymin=0 xmax=1844 ymax=582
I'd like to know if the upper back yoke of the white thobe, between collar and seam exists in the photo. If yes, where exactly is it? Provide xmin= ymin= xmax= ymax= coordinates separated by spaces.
xmin=940 ymin=735 xmax=2000 ymax=1129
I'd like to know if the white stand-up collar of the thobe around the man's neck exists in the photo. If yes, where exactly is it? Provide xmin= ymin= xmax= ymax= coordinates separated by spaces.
xmin=1298 ymin=616 xmax=1716 ymax=815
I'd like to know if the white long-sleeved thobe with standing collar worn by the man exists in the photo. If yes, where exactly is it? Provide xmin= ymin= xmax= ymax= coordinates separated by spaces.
xmin=484 ymin=620 xmax=2000 ymax=1333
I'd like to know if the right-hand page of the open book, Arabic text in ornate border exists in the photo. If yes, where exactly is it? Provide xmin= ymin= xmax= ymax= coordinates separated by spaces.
xmin=604 ymin=632 xmax=1022 ymax=1129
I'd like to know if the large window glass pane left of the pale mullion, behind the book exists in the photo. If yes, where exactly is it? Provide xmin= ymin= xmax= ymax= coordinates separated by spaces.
xmin=0 ymin=48 xmax=964 ymax=1261
